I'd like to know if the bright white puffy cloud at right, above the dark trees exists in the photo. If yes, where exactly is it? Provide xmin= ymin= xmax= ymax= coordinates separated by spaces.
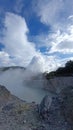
xmin=35 ymin=16 xmax=73 ymax=55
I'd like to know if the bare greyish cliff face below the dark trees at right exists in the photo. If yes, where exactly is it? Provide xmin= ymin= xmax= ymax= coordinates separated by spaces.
xmin=45 ymin=76 xmax=73 ymax=93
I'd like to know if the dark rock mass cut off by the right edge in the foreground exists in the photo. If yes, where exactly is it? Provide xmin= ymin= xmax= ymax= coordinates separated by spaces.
xmin=60 ymin=86 xmax=73 ymax=126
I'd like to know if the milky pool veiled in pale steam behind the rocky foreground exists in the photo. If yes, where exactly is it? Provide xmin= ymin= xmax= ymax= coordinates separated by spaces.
xmin=0 ymin=65 xmax=47 ymax=103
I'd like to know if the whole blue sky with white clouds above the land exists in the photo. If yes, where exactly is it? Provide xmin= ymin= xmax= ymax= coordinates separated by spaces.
xmin=0 ymin=0 xmax=73 ymax=72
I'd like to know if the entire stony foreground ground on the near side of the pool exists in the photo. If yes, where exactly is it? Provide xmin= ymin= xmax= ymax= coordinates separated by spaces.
xmin=0 ymin=86 xmax=73 ymax=130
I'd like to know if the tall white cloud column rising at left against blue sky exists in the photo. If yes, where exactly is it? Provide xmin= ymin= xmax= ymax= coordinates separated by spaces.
xmin=1 ymin=13 xmax=37 ymax=66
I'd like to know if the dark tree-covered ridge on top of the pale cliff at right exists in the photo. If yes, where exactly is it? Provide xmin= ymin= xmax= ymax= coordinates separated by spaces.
xmin=46 ymin=60 xmax=73 ymax=79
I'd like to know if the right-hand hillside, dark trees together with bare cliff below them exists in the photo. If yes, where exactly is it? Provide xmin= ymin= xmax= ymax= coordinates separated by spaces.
xmin=44 ymin=61 xmax=73 ymax=94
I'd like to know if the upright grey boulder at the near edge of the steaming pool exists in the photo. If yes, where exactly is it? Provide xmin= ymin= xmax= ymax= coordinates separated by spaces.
xmin=39 ymin=96 xmax=60 ymax=119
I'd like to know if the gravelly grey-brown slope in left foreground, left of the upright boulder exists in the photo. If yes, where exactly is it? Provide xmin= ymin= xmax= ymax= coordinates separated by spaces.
xmin=0 ymin=85 xmax=42 ymax=130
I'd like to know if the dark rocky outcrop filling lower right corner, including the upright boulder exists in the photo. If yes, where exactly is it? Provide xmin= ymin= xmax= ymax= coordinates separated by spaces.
xmin=39 ymin=86 xmax=73 ymax=130
